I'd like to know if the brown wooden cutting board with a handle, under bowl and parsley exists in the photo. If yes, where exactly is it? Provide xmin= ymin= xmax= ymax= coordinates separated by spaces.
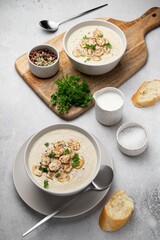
xmin=15 ymin=7 xmax=160 ymax=120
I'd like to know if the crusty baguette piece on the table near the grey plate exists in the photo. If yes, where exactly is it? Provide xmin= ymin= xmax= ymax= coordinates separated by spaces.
xmin=99 ymin=190 xmax=134 ymax=232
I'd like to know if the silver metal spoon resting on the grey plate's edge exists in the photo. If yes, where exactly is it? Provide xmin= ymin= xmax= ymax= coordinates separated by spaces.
xmin=23 ymin=165 xmax=113 ymax=237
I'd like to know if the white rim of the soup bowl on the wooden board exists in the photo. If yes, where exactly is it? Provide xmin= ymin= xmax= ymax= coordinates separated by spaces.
xmin=63 ymin=19 xmax=127 ymax=67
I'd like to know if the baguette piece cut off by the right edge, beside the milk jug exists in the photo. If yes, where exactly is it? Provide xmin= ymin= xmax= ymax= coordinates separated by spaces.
xmin=131 ymin=80 xmax=160 ymax=107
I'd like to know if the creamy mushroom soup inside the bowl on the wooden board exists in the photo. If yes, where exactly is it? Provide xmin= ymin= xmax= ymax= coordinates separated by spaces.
xmin=67 ymin=25 xmax=123 ymax=65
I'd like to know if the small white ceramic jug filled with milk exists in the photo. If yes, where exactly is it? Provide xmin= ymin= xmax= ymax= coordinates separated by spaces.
xmin=93 ymin=87 xmax=125 ymax=126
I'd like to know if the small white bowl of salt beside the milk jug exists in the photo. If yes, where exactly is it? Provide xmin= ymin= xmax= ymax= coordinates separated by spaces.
xmin=117 ymin=122 xmax=148 ymax=156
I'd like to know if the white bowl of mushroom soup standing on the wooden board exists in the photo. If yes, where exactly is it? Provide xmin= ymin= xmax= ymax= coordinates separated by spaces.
xmin=63 ymin=20 xmax=127 ymax=75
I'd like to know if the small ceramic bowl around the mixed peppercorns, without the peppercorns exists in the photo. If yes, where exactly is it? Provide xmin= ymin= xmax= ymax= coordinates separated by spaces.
xmin=28 ymin=44 xmax=59 ymax=78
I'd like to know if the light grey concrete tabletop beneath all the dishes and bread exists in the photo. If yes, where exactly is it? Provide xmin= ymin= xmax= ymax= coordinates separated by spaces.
xmin=0 ymin=0 xmax=160 ymax=240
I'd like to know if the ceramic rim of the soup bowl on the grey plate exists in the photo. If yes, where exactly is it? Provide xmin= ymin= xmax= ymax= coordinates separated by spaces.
xmin=24 ymin=124 xmax=101 ymax=196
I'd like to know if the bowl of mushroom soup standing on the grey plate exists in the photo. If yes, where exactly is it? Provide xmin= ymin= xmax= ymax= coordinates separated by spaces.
xmin=24 ymin=124 xmax=101 ymax=196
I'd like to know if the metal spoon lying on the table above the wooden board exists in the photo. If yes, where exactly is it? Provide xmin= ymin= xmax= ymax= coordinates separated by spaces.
xmin=39 ymin=3 xmax=108 ymax=32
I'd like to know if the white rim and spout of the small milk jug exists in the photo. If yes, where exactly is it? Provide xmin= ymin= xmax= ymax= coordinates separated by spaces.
xmin=93 ymin=87 xmax=125 ymax=112
